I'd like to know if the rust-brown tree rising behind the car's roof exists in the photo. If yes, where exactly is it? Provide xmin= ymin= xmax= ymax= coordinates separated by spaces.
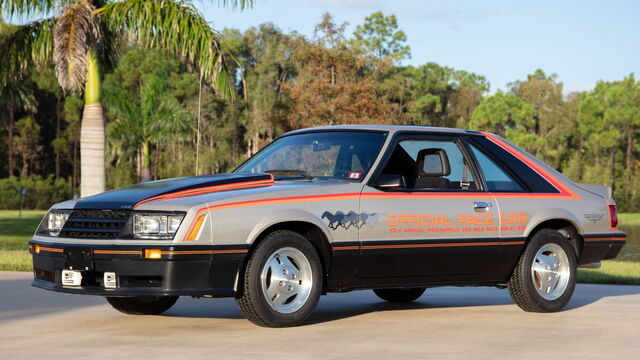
xmin=284 ymin=18 xmax=399 ymax=128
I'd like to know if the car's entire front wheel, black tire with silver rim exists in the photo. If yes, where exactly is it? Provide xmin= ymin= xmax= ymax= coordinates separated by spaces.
xmin=236 ymin=231 xmax=323 ymax=327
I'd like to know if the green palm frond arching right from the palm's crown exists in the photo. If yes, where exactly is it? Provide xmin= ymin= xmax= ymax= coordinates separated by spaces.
xmin=96 ymin=0 xmax=239 ymax=98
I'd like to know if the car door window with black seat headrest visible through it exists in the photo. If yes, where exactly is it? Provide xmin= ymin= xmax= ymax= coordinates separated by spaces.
xmin=383 ymin=139 xmax=477 ymax=190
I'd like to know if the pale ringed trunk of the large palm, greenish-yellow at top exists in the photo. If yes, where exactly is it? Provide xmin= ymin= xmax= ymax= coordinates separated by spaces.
xmin=80 ymin=52 xmax=105 ymax=197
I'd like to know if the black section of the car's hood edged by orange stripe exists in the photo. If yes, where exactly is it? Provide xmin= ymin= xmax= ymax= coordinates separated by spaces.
xmin=74 ymin=173 xmax=272 ymax=210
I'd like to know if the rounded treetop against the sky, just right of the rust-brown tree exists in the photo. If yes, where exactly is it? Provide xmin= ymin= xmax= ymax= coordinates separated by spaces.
xmin=353 ymin=11 xmax=411 ymax=62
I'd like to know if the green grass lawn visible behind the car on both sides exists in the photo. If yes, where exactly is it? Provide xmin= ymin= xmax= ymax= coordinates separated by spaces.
xmin=0 ymin=210 xmax=640 ymax=285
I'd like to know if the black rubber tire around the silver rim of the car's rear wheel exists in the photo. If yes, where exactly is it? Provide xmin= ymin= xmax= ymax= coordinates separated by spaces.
xmin=507 ymin=229 xmax=578 ymax=312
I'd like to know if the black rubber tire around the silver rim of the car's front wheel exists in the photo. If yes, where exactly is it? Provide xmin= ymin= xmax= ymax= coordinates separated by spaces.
xmin=236 ymin=230 xmax=324 ymax=327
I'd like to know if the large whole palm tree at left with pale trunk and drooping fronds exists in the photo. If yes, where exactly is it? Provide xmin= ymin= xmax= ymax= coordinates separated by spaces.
xmin=0 ymin=0 xmax=253 ymax=196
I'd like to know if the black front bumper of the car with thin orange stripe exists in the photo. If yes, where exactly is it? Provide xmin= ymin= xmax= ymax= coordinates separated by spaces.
xmin=29 ymin=240 xmax=248 ymax=297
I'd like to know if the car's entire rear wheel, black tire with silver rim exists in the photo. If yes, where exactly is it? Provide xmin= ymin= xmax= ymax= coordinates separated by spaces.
xmin=508 ymin=229 xmax=577 ymax=312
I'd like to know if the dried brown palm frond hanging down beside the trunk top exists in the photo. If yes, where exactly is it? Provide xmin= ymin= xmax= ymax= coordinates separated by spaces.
xmin=53 ymin=1 xmax=99 ymax=91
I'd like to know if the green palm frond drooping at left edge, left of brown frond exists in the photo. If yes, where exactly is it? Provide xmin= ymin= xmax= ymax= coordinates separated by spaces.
xmin=0 ymin=19 xmax=54 ymax=85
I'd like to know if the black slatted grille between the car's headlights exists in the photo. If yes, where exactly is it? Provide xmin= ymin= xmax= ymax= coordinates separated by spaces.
xmin=60 ymin=210 xmax=131 ymax=239
